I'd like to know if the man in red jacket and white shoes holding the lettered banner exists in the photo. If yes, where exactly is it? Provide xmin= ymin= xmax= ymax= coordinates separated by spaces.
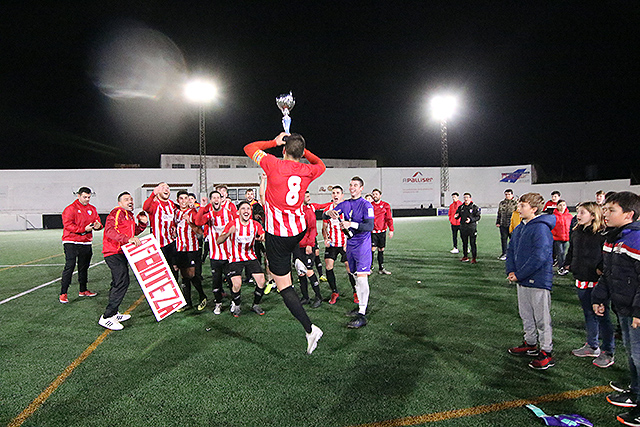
xmin=98 ymin=191 xmax=149 ymax=331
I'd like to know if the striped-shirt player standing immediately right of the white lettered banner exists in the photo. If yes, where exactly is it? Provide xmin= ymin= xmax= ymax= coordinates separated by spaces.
xmin=175 ymin=190 xmax=207 ymax=311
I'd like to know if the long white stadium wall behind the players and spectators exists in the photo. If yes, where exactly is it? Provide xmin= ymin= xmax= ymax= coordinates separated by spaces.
xmin=0 ymin=165 xmax=640 ymax=230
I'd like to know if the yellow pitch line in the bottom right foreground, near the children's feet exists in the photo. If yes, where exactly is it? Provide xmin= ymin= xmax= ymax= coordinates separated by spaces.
xmin=354 ymin=385 xmax=611 ymax=427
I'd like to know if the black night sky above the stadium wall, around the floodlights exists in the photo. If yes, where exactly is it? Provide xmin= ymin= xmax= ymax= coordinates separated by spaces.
xmin=0 ymin=0 xmax=640 ymax=181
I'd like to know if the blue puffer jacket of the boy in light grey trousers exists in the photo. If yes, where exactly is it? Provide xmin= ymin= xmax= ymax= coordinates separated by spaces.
xmin=506 ymin=215 xmax=556 ymax=290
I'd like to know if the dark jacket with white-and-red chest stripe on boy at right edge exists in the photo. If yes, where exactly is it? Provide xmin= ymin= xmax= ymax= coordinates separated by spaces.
xmin=591 ymin=222 xmax=640 ymax=318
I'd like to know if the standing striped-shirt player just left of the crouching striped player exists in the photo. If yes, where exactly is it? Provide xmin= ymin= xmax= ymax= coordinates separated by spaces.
xmin=195 ymin=191 xmax=234 ymax=315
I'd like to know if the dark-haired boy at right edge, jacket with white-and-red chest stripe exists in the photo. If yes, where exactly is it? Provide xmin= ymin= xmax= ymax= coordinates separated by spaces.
xmin=591 ymin=191 xmax=640 ymax=426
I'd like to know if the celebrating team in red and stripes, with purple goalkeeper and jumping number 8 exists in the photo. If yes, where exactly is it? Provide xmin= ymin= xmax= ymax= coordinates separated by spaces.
xmin=59 ymin=133 xmax=393 ymax=354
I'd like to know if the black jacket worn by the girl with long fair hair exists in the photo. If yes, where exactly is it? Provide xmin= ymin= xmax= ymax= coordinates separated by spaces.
xmin=564 ymin=225 xmax=605 ymax=282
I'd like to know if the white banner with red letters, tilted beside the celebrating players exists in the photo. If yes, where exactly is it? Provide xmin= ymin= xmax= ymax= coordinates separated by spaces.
xmin=122 ymin=235 xmax=187 ymax=322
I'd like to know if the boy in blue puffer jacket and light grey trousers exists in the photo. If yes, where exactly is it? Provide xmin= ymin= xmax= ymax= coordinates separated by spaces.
xmin=506 ymin=193 xmax=556 ymax=369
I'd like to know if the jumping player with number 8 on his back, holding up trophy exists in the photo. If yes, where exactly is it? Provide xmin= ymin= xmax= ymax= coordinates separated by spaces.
xmin=244 ymin=132 xmax=326 ymax=354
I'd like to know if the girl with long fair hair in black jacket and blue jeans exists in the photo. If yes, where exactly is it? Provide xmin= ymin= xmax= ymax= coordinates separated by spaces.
xmin=564 ymin=202 xmax=615 ymax=368
